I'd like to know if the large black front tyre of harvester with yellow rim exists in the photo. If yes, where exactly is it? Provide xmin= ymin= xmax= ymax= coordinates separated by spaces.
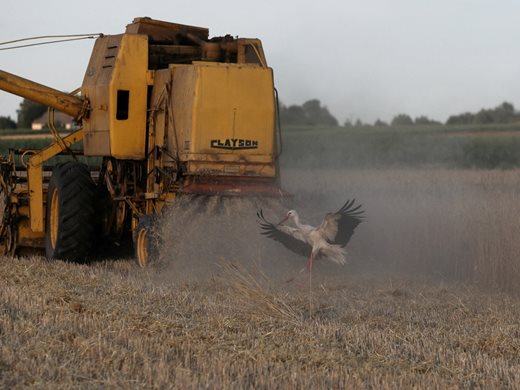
xmin=45 ymin=161 xmax=96 ymax=262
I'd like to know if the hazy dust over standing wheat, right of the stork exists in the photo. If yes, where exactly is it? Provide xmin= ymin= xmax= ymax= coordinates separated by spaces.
xmin=285 ymin=168 xmax=520 ymax=291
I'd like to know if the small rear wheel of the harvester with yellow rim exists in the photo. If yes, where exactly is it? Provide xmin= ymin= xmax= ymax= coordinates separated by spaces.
xmin=134 ymin=215 xmax=161 ymax=268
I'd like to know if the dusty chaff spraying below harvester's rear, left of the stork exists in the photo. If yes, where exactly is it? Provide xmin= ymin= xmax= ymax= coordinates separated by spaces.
xmin=154 ymin=195 xmax=304 ymax=281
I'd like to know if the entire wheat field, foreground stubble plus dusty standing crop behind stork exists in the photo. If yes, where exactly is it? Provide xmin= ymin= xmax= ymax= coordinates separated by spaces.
xmin=0 ymin=169 xmax=520 ymax=389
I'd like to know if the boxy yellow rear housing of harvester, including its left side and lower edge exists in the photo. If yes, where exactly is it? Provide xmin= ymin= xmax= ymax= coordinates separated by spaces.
xmin=171 ymin=62 xmax=276 ymax=176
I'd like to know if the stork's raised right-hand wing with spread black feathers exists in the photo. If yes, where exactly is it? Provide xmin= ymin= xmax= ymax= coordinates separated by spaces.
xmin=318 ymin=199 xmax=364 ymax=246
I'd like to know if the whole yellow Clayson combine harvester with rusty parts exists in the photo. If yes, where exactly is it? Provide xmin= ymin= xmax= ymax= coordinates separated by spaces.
xmin=0 ymin=18 xmax=279 ymax=267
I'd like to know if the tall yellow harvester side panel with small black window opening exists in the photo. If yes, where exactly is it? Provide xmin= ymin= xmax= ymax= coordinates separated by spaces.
xmin=82 ymin=34 xmax=149 ymax=159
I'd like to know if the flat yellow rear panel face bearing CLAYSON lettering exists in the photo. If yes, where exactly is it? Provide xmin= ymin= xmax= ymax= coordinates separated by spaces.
xmin=192 ymin=64 xmax=275 ymax=161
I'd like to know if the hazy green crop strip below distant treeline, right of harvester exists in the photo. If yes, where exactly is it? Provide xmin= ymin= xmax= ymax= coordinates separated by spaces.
xmin=282 ymin=125 xmax=520 ymax=169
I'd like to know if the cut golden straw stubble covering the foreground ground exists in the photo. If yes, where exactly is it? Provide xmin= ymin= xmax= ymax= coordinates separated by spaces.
xmin=0 ymin=259 xmax=520 ymax=389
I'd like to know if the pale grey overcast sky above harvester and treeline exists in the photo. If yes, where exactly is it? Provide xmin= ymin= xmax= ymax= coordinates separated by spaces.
xmin=0 ymin=0 xmax=520 ymax=122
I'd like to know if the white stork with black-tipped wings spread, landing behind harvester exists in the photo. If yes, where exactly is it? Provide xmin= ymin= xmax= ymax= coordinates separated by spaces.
xmin=257 ymin=199 xmax=364 ymax=271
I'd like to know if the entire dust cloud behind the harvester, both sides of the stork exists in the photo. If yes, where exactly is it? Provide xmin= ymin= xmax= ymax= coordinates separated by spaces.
xmin=151 ymin=164 xmax=520 ymax=290
